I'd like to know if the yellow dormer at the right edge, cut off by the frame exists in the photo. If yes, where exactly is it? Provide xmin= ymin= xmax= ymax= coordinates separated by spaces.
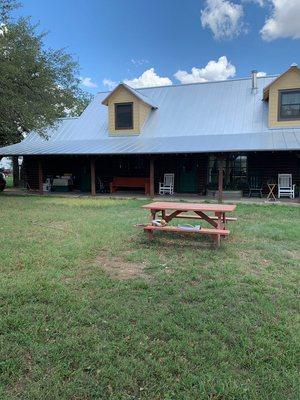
xmin=264 ymin=65 xmax=300 ymax=128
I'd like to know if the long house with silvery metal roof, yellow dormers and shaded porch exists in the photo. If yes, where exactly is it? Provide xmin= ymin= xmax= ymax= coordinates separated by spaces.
xmin=0 ymin=64 xmax=300 ymax=195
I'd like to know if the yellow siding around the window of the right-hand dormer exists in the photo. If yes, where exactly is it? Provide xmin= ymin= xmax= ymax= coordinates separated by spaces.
xmin=269 ymin=68 xmax=300 ymax=128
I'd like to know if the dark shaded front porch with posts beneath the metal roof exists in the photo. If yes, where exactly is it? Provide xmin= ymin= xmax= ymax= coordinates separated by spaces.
xmin=18 ymin=152 xmax=300 ymax=201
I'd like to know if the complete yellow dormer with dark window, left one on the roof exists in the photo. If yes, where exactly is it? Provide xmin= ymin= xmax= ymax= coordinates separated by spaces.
xmin=102 ymin=83 xmax=157 ymax=135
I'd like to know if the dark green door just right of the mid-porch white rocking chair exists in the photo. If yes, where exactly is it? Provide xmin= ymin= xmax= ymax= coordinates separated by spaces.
xmin=178 ymin=157 xmax=199 ymax=193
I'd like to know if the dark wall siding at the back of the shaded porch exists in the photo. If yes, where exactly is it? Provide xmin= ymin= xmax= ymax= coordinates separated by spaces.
xmin=24 ymin=152 xmax=300 ymax=194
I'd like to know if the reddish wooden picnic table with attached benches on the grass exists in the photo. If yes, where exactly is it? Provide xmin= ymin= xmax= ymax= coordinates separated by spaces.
xmin=142 ymin=201 xmax=236 ymax=246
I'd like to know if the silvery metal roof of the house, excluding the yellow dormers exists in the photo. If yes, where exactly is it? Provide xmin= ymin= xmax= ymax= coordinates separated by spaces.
xmin=0 ymin=77 xmax=300 ymax=155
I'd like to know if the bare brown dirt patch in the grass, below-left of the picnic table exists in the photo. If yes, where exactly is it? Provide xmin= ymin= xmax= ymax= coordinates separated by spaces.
xmin=93 ymin=253 xmax=149 ymax=280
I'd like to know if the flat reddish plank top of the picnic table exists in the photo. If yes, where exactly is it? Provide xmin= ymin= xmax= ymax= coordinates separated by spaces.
xmin=142 ymin=201 xmax=236 ymax=212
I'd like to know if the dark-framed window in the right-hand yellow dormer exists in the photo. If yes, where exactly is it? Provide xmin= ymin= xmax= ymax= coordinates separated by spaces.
xmin=279 ymin=90 xmax=300 ymax=120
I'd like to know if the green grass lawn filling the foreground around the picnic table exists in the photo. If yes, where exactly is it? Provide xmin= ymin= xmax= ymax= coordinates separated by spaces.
xmin=0 ymin=195 xmax=300 ymax=400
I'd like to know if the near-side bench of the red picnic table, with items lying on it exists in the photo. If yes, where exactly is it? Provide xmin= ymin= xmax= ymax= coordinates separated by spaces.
xmin=144 ymin=225 xmax=230 ymax=246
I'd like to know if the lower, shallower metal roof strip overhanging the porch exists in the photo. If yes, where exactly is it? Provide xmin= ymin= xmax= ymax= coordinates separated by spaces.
xmin=1 ymin=129 xmax=300 ymax=156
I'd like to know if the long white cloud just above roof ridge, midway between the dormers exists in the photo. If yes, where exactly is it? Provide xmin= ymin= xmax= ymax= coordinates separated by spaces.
xmin=174 ymin=56 xmax=236 ymax=83
